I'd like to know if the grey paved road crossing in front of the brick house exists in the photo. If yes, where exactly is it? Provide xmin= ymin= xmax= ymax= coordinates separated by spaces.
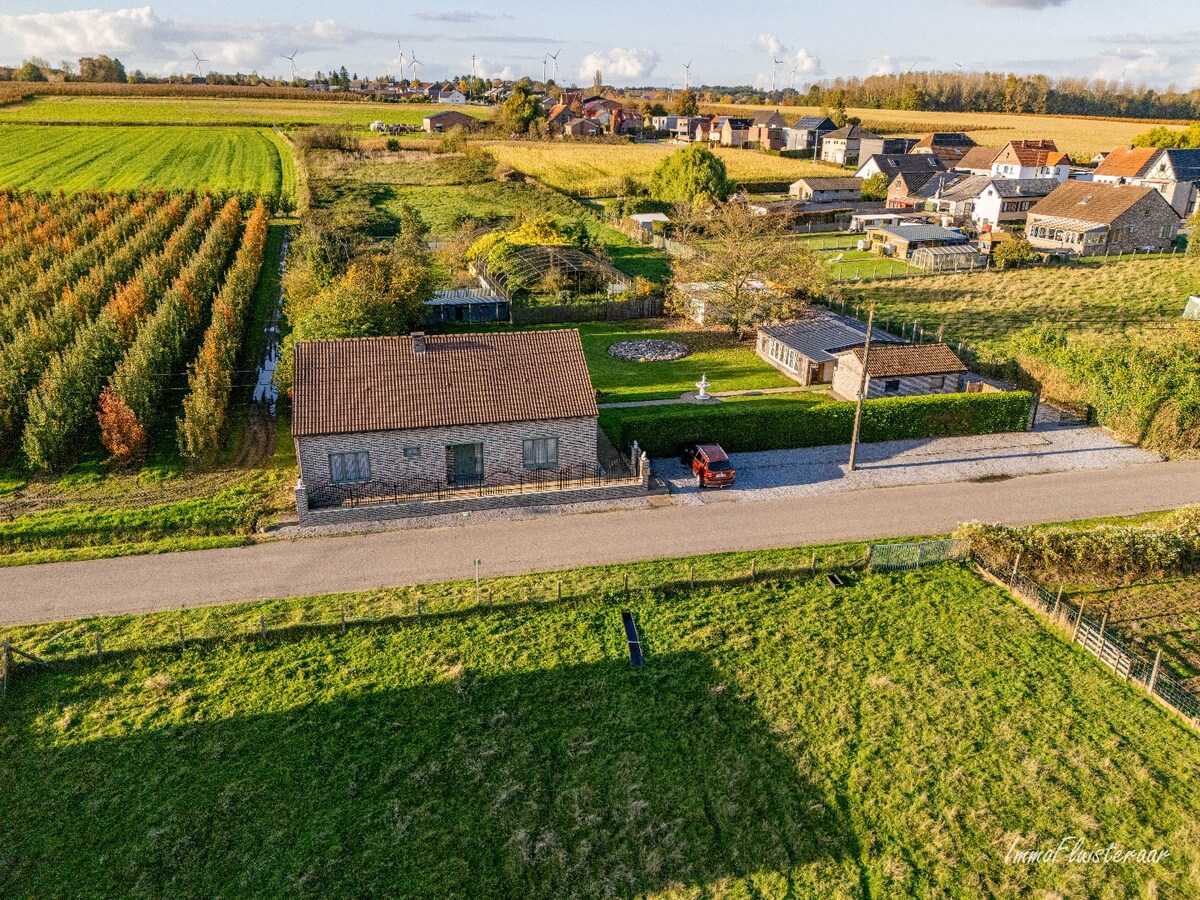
xmin=0 ymin=460 xmax=1200 ymax=624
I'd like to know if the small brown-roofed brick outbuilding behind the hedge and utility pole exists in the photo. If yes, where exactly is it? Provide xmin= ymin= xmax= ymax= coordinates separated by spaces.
xmin=833 ymin=343 xmax=967 ymax=400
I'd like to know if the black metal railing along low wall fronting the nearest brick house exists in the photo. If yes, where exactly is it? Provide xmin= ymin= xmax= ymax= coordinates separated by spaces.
xmin=308 ymin=466 xmax=640 ymax=509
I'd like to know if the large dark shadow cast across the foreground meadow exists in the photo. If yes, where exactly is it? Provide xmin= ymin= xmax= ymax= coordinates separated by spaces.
xmin=0 ymin=653 xmax=858 ymax=898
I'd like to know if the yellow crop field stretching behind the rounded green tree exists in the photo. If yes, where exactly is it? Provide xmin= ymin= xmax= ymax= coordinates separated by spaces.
xmin=477 ymin=140 xmax=845 ymax=197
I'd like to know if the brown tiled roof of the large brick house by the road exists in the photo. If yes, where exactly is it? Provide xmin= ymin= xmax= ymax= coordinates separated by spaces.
xmin=292 ymin=329 xmax=596 ymax=437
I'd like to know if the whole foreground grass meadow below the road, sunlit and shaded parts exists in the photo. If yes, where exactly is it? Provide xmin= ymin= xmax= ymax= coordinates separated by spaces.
xmin=0 ymin=561 xmax=1200 ymax=898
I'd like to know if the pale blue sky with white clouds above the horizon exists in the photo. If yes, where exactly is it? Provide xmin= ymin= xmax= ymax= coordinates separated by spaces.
xmin=0 ymin=0 xmax=1200 ymax=88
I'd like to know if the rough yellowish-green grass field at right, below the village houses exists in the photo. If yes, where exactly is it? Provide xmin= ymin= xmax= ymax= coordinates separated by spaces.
xmin=841 ymin=254 xmax=1200 ymax=361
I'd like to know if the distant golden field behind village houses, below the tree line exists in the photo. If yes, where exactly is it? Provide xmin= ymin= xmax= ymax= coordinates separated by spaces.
xmin=703 ymin=103 xmax=1187 ymax=158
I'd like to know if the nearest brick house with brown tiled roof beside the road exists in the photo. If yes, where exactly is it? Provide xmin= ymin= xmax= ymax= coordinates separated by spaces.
xmin=292 ymin=329 xmax=598 ymax=521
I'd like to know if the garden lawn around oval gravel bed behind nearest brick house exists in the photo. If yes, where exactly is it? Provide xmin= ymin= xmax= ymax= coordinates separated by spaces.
xmin=568 ymin=319 xmax=797 ymax=403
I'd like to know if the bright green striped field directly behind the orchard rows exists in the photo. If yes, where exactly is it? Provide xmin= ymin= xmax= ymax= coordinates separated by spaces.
xmin=0 ymin=125 xmax=296 ymax=197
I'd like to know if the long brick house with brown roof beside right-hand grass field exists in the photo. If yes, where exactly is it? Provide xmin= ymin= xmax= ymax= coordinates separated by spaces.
xmin=1025 ymin=181 xmax=1180 ymax=256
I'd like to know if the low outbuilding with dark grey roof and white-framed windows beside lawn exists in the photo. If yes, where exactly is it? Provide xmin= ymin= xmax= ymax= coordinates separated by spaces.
xmin=755 ymin=310 xmax=902 ymax=386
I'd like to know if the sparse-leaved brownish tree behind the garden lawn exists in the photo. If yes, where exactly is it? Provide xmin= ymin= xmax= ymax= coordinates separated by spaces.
xmin=671 ymin=200 xmax=828 ymax=336
